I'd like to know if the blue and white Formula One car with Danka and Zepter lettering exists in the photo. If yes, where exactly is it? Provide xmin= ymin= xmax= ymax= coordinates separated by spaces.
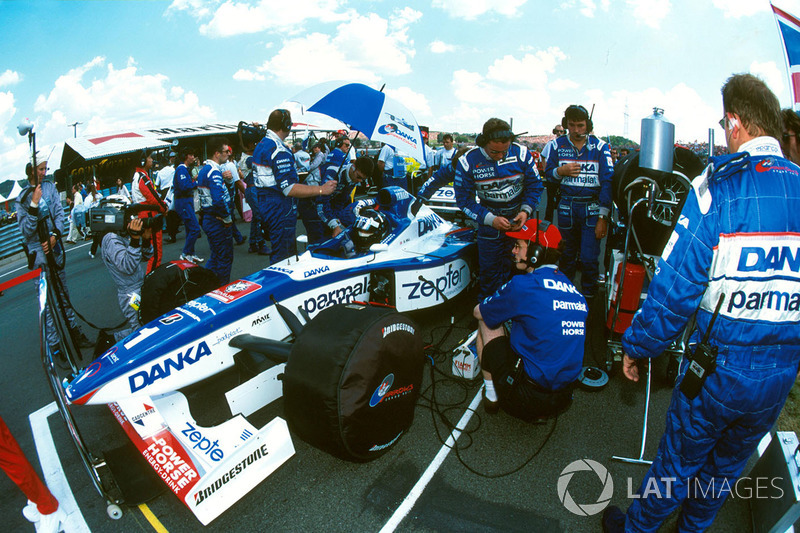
xmin=42 ymin=187 xmax=476 ymax=524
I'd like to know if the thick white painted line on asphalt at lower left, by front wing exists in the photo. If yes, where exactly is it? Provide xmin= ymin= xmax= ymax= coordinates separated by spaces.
xmin=28 ymin=402 xmax=91 ymax=533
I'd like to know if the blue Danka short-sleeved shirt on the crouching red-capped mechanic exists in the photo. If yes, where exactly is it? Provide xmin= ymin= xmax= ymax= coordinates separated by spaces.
xmin=480 ymin=265 xmax=588 ymax=391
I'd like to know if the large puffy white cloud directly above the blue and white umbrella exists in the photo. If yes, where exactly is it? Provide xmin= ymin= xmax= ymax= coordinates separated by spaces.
xmin=256 ymin=8 xmax=422 ymax=85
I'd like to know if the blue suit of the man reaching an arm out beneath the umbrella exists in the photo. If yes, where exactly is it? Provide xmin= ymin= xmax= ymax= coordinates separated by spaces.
xmin=253 ymin=130 xmax=298 ymax=264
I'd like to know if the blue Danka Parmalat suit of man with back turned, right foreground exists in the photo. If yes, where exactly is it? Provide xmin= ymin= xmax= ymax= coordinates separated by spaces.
xmin=622 ymin=137 xmax=800 ymax=531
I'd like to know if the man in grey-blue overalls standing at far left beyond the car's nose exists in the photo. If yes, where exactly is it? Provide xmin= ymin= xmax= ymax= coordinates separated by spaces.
xmin=15 ymin=157 xmax=93 ymax=362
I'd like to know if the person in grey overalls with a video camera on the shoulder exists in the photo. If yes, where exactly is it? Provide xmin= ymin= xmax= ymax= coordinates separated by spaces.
xmin=101 ymin=217 xmax=153 ymax=341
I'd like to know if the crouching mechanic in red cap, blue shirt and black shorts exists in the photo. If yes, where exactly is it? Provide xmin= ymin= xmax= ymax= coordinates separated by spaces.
xmin=473 ymin=219 xmax=588 ymax=421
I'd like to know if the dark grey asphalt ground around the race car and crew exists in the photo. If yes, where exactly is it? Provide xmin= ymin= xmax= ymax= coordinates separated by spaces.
xmin=0 ymin=233 xmax=751 ymax=532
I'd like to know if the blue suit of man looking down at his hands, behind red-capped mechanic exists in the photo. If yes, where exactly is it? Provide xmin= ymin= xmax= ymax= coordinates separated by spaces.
xmin=453 ymin=143 xmax=543 ymax=299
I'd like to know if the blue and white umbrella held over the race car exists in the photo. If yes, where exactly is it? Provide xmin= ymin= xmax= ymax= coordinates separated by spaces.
xmin=289 ymin=81 xmax=425 ymax=163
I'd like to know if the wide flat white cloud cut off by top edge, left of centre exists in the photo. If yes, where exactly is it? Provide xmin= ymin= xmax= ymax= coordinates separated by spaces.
xmin=168 ymin=0 xmax=355 ymax=37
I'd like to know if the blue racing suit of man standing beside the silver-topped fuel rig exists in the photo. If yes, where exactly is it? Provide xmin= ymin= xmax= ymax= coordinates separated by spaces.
xmin=545 ymin=135 xmax=614 ymax=296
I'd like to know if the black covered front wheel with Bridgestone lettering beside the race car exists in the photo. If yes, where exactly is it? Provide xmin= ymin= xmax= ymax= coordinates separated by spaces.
xmin=283 ymin=304 xmax=425 ymax=462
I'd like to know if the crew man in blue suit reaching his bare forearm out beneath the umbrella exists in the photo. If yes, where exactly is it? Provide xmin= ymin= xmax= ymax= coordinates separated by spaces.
xmin=253 ymin=109 xmax=336 ymax=264
